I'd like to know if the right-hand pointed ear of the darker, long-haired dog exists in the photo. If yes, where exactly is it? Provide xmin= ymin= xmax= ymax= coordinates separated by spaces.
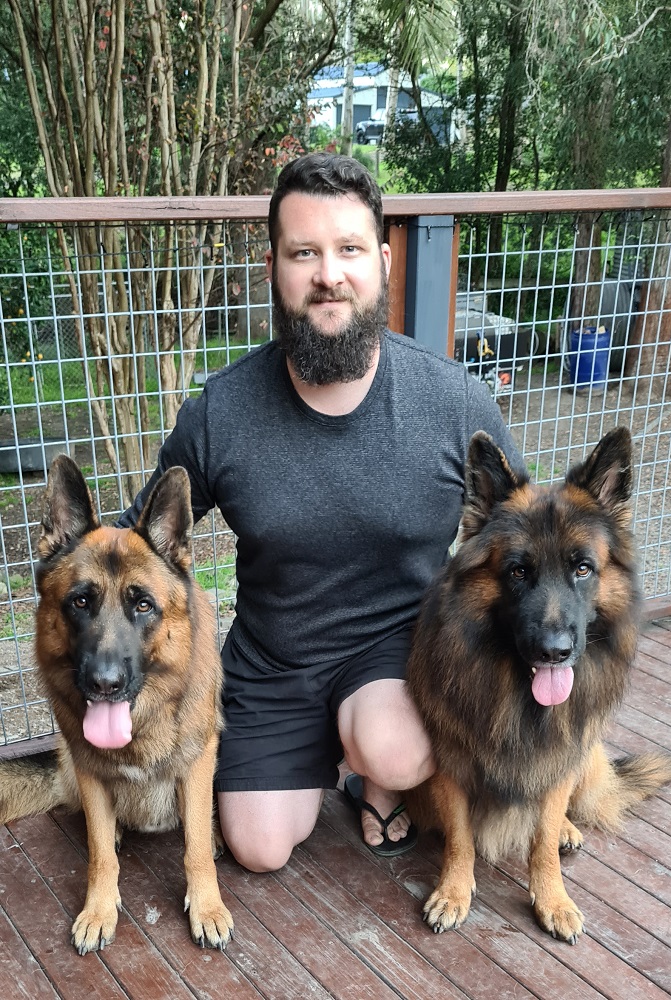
xmin=566 ymin=427 xmax=634 ymax=528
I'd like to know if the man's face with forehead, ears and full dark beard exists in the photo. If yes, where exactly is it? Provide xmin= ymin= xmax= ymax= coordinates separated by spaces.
xmin=266 ymin=192 xmax=391 ymax=385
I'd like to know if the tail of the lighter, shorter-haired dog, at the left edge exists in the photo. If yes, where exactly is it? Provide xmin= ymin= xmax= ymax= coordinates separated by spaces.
xmin=0 ymin=752 xmax=73 ymax=824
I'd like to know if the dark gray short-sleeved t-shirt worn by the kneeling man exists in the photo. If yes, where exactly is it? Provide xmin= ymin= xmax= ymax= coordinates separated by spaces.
xmin=119 ymin=332 xmax=523 ymax=667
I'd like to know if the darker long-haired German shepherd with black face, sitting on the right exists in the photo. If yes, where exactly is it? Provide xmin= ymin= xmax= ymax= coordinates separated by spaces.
xmin=407 ymin=428 xmax=671 ymax=944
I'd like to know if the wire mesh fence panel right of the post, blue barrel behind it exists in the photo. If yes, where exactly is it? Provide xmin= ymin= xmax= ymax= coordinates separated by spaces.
xmin=455 ymin=212 xmax=671 ymax=598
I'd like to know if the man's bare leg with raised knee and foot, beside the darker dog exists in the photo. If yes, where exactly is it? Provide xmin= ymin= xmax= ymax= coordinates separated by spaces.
xmin=338 ymin=678 xmax=435 ymax=847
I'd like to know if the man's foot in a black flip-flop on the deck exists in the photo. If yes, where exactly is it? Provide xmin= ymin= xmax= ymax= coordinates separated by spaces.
xmin=344 ymin=774 xmax=417 ymax=857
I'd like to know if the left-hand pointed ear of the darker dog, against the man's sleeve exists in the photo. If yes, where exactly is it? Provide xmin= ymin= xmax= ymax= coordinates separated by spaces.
xmin=461 ymin=431 xmax=529 ymax=538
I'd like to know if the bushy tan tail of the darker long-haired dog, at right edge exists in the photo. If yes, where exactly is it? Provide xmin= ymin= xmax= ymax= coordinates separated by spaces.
xmin=569 ymin=745 xmax=671 ymax=831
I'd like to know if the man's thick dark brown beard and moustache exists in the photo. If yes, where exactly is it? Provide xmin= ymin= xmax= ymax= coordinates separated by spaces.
xmin=273 ymin=272 xmax=388 ymax=385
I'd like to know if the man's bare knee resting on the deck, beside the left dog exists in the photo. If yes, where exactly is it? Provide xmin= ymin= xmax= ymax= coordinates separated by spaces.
xmin=217 ymin=788 xmax=324 ymax=872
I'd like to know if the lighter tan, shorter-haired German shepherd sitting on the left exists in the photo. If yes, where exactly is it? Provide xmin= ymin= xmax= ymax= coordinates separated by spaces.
xmin=0 ymin=455 xmax=233 ymax=955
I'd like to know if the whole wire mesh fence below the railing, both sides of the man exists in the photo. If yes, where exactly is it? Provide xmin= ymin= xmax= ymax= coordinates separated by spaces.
xmin=0 ymin=203 xmax=671 ymax=746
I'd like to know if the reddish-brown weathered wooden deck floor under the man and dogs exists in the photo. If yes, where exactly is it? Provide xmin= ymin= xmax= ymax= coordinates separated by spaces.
xmin=0 ymin=619 xmax=671 ymax=1000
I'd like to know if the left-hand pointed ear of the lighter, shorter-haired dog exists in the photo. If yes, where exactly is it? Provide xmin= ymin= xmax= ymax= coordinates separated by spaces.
xmin=37 ymin=455 xmax=100 ymax=559
